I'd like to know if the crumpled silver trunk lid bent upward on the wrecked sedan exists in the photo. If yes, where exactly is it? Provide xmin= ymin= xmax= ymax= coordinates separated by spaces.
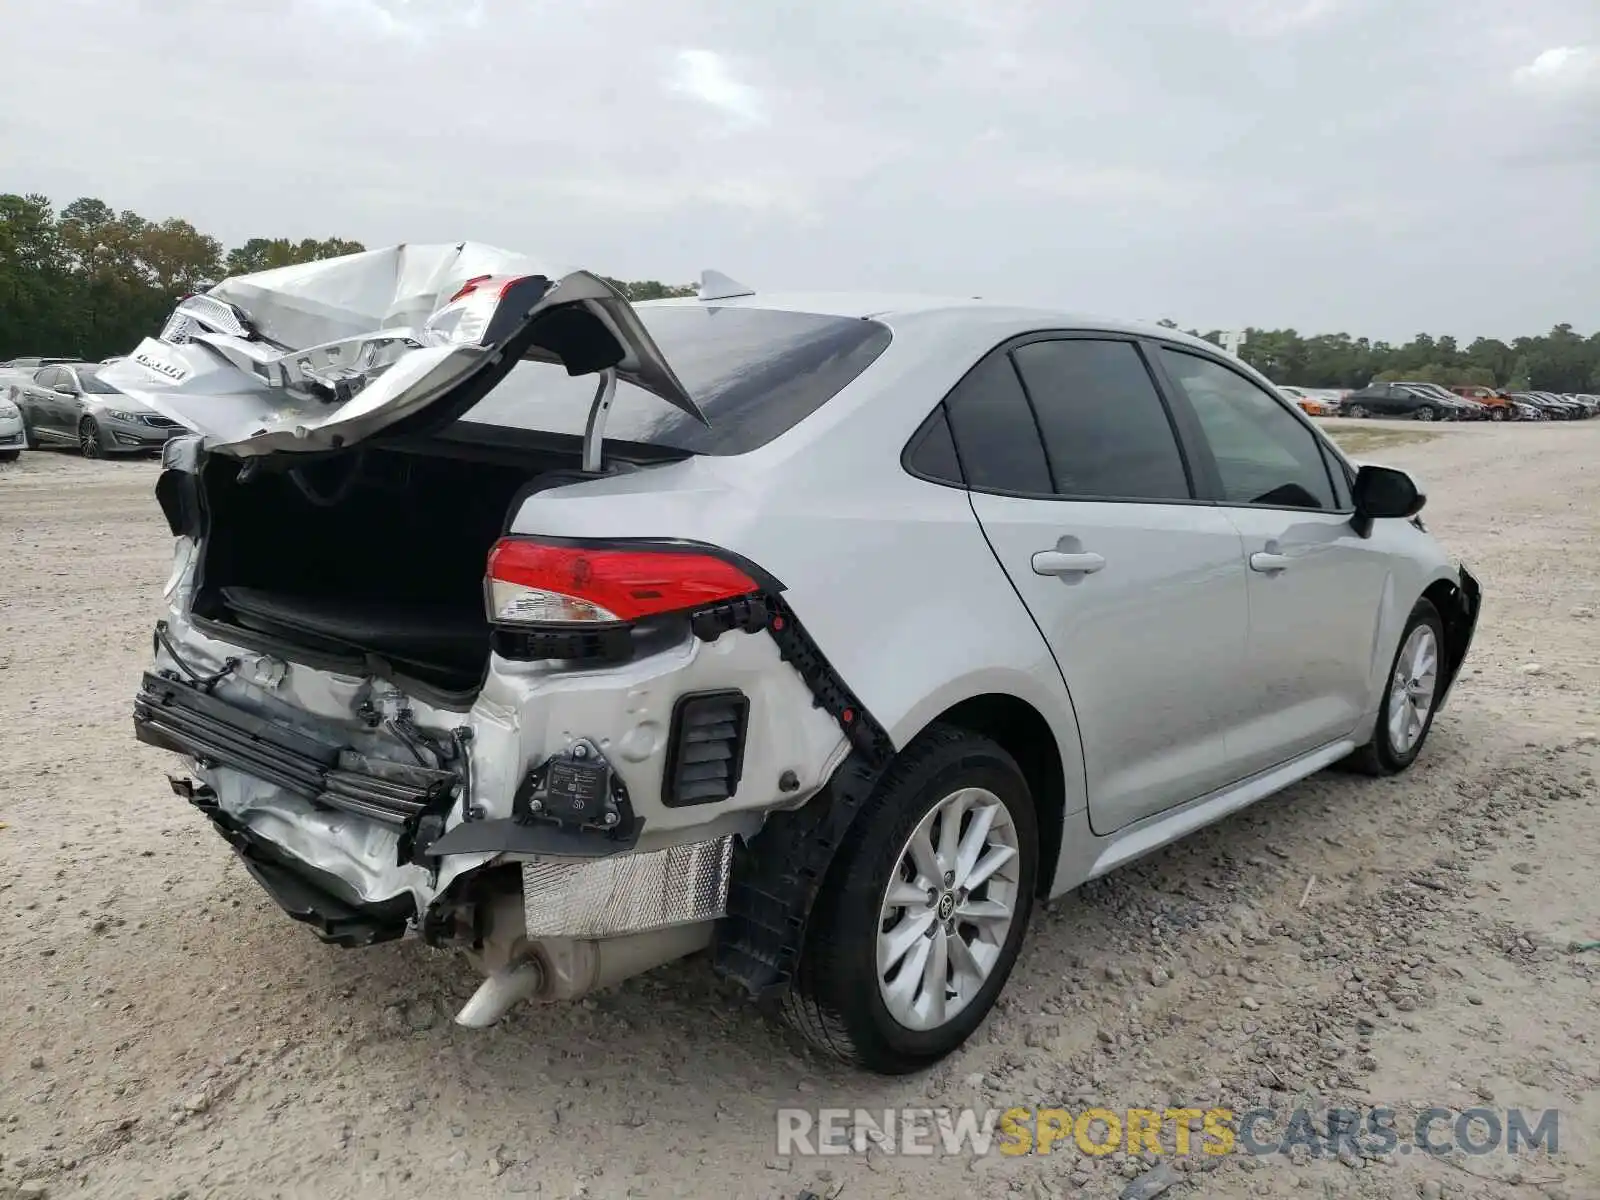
xmin=101 ymin=242 xmax=706 ymax=458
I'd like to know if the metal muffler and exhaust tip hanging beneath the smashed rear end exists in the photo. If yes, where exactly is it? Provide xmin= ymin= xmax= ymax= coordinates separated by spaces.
xmin=456 ymin=922 xmax=715 ymax=1029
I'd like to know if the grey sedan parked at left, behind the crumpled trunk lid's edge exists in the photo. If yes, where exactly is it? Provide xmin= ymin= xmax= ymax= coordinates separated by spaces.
xmin=16 ymin=363 xmax=184 ymax=458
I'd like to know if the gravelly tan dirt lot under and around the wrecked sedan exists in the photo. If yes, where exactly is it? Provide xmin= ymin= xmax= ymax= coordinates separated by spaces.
xmin=0 ymin=421 xmax=1600 ymax=1200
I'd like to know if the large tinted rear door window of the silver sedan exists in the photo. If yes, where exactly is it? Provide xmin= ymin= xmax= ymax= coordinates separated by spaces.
xmin=1011 ymin=338 xmax=1192 ymax=501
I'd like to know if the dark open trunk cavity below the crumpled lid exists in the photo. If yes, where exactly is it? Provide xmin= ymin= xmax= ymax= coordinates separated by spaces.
xmin=194 ymin=445 xmax=571 ymax=696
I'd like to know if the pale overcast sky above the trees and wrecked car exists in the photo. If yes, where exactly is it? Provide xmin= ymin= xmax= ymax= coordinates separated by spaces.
xmin=0 ymin=0 xmax=1600 ymax=338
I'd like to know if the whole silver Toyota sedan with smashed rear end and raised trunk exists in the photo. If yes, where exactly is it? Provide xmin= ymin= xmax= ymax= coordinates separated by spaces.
xmin=118 ymin=243 xmax=1480 ymax=1072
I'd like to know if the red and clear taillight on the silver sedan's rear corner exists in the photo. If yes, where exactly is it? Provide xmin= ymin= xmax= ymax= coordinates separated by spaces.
xmin=488 ymin=538 xmax=760 ymax=626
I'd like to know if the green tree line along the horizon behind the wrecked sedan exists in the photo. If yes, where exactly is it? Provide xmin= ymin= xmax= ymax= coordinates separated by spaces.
xmin=0 ymin=194 xmax=1600 ymax=392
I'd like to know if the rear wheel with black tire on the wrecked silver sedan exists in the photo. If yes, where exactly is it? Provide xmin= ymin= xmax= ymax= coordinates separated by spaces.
xmin=786 ymin=725 xmax=1038 ymax=1075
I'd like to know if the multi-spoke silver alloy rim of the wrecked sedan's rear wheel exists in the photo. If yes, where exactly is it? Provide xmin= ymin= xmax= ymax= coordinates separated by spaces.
xmin=877 ymin=787 xmax=1021 ymax=1030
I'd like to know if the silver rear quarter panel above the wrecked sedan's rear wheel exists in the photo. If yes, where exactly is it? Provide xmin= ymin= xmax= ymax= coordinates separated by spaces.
xmin=512 ymin=310 xmax=1085 ymax=811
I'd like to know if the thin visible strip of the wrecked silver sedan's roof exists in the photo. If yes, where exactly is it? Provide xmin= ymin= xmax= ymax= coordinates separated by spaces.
xmin=634 ymin=291 xmax=1221 ymax=354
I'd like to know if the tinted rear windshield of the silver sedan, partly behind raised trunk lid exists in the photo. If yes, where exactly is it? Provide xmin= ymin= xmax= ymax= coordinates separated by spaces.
xmin=459 ymin=304 xmax=891 ymax=454
